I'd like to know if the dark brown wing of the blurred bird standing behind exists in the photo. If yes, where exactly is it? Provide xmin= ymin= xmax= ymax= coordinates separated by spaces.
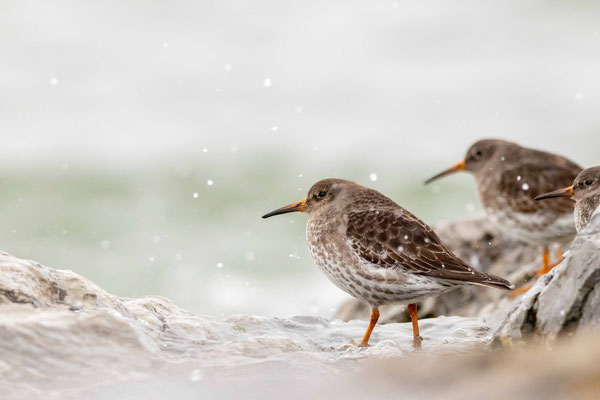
xmin=500 ymin=161 xmax=582 ymax=214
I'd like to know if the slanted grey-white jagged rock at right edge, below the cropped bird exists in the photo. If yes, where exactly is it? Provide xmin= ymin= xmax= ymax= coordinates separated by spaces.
xmin=494 ymin=209 xmax=600 ymax=346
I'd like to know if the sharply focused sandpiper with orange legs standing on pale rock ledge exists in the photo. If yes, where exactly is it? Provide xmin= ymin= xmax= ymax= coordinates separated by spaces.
xmin=263 ymin=179 xmax=512 ymax=347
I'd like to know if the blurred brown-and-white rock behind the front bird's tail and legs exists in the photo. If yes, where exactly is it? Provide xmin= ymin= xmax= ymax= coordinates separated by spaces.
xmin=335 ymin=215 xmax=542 ymax=329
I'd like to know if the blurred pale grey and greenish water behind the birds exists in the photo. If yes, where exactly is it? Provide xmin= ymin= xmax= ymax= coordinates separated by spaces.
xmin=0 ymin=0 xmax=600 ymax=317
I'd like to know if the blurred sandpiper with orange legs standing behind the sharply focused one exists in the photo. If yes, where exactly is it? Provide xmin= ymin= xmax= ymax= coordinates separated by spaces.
xmin=426 ymin=139 xmax=581 ymax=282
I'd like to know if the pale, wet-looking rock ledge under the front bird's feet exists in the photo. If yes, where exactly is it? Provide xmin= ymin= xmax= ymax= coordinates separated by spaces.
xmin=0 ymin=253 xmax=491 ymax=399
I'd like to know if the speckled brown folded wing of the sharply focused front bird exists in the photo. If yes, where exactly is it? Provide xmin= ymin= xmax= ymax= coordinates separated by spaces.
xmin=346 ymin=207 xmax=511 ymax=289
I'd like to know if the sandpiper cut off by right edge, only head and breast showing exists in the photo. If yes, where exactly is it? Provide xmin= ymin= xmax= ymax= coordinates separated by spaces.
xmin=535 ymin=167 xmax=600 ymax=232
